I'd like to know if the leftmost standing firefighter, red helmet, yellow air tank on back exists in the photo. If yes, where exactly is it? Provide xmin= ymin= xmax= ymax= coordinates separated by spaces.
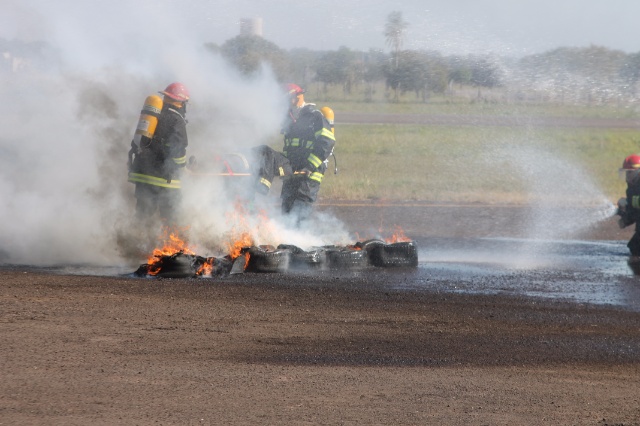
xmin=129 ymin=82 xmax=189 ymax=223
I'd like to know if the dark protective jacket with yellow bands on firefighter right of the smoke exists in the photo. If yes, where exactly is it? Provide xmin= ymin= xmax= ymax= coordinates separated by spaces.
xmin=283 ymin=104 xmax=336 ymax=183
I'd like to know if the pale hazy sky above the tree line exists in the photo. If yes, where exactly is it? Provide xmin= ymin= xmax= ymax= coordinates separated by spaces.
xmin=0 ymin=0 xmax=640 ymax=56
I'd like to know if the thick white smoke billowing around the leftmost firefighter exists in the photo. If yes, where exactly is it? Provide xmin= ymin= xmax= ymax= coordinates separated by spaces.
xmin=0 ymin=0 xmax=344 ymax=265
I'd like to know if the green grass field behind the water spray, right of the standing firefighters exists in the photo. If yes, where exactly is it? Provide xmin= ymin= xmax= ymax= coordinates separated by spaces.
xmin=300 ymin=96 xmax=640 ymax=204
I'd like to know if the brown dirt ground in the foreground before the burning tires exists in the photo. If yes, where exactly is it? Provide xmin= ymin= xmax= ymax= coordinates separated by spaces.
xmin=0 ymin=206 xmax=640 ymax=426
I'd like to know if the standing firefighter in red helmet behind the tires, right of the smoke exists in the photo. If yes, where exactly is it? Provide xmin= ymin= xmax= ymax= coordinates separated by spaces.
xmin=281 ymin=83 xmax=336 ymax=224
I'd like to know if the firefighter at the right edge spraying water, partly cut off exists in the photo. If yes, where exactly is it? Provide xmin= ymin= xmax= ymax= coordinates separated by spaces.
xmin=616 ymin=154 xmax=640 ymax=256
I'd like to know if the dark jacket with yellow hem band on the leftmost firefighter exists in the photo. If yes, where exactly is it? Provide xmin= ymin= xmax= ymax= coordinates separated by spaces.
xmin=129 ymin=102 xmax=189 ymax=189
